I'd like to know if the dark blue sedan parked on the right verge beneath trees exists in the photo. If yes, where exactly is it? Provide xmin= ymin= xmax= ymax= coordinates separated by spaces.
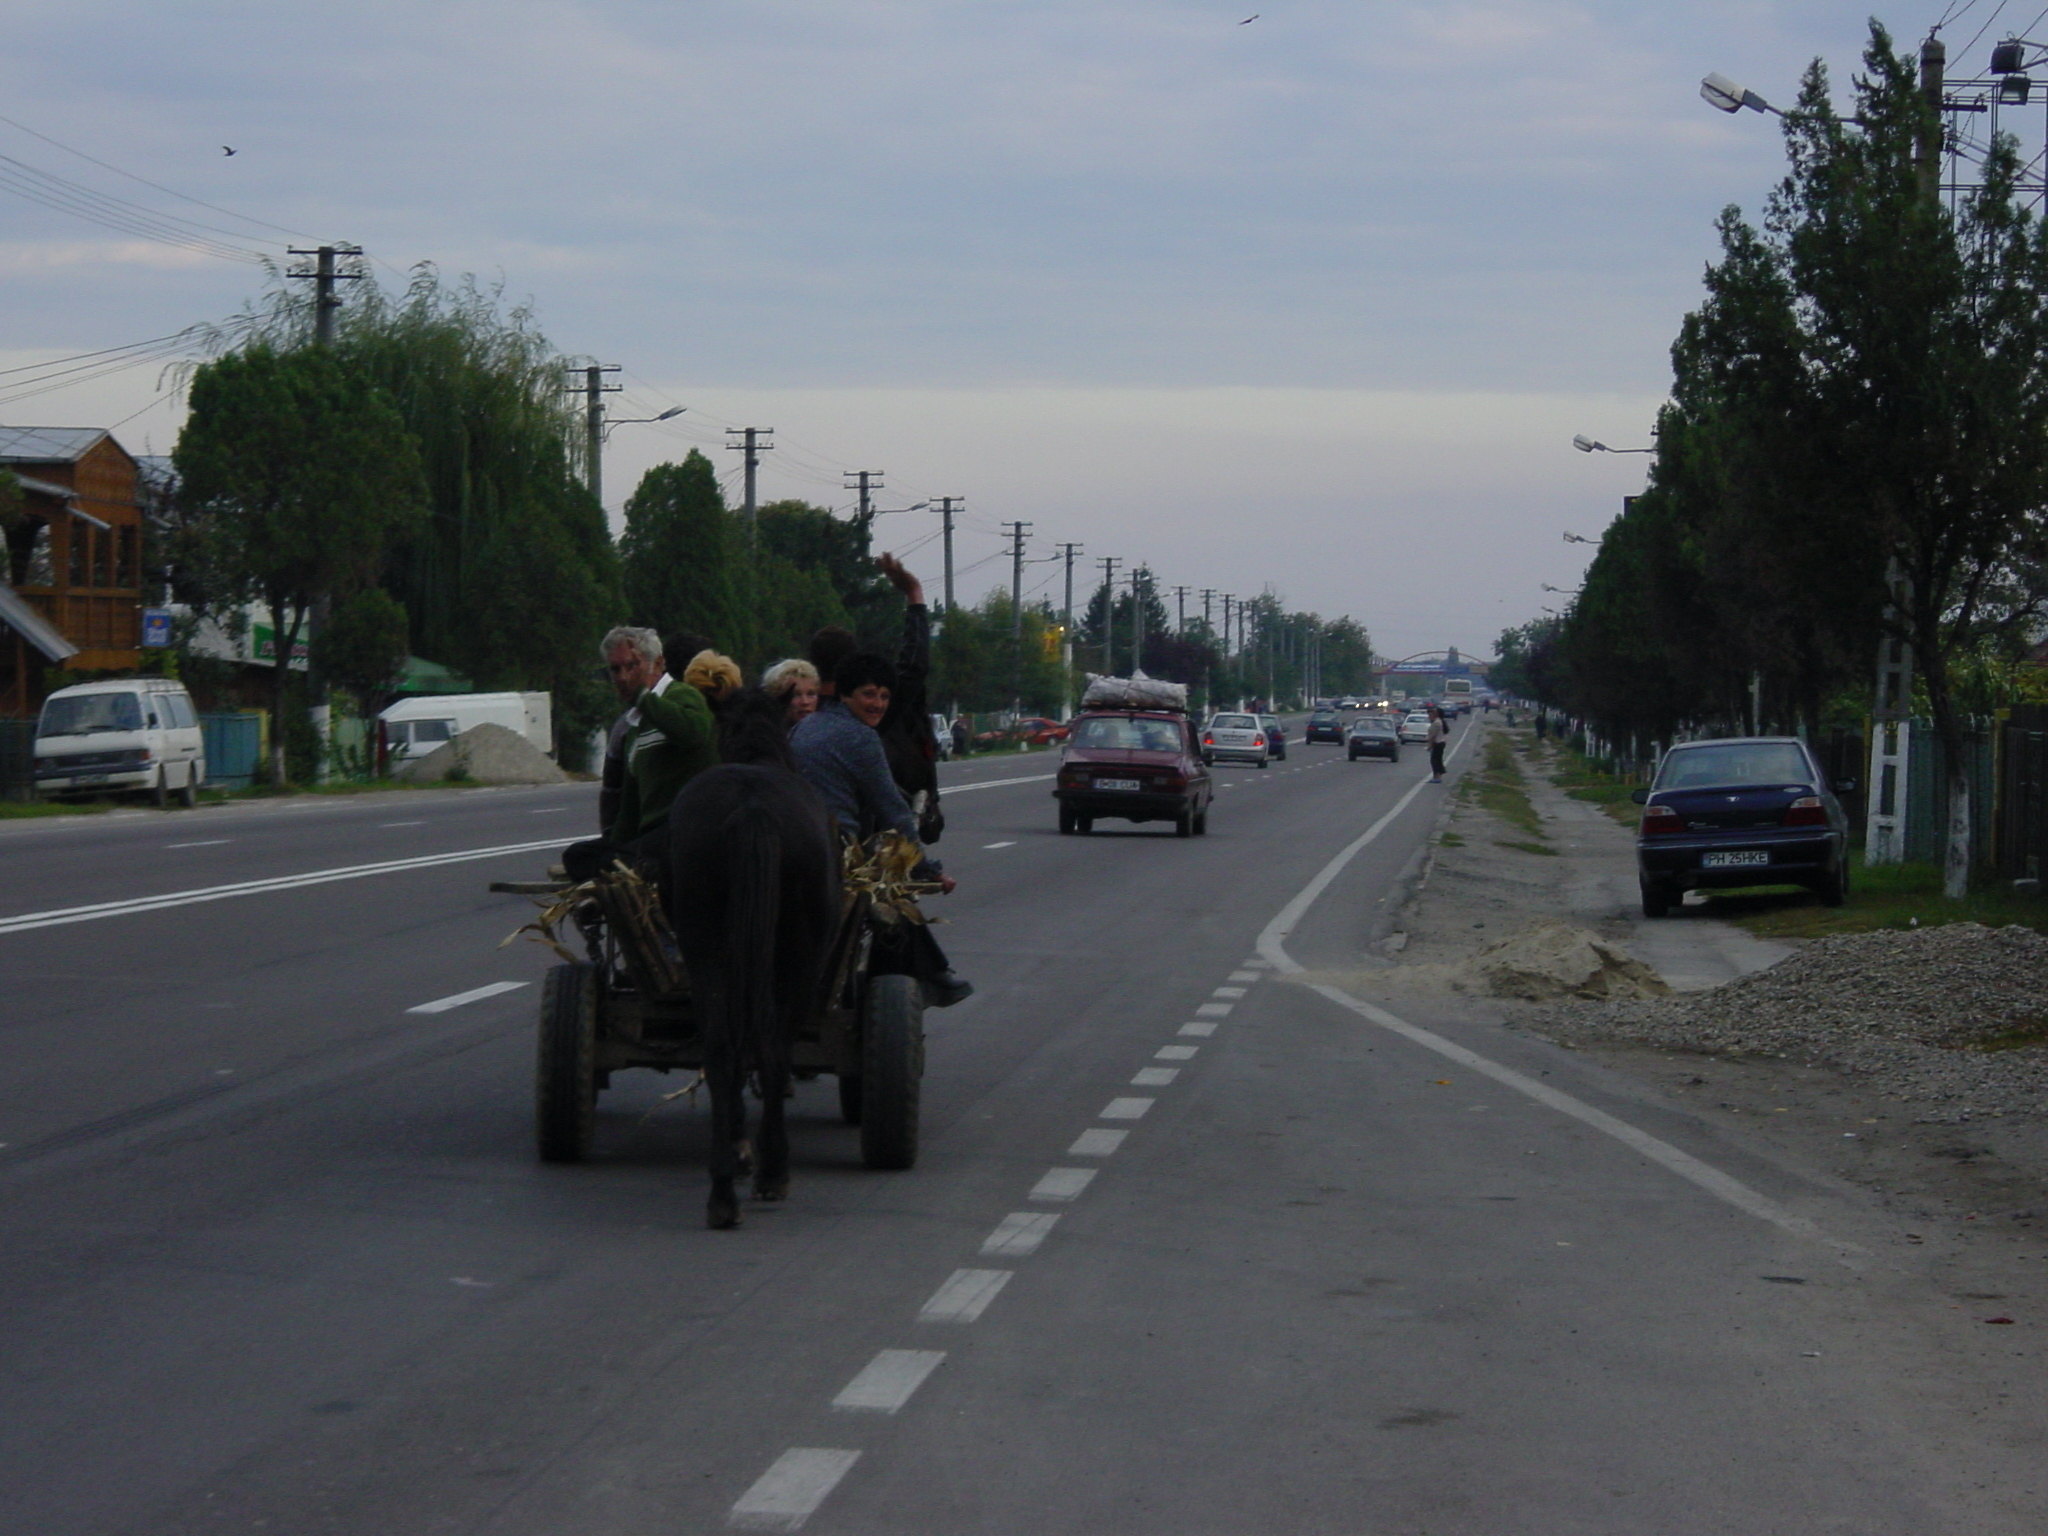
xmin=1634 ymin=735 xmax=1853 ymax=918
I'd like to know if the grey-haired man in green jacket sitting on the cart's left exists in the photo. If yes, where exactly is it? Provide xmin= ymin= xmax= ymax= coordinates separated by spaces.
xmin=561 ymin=627 xmax=719 ymax=881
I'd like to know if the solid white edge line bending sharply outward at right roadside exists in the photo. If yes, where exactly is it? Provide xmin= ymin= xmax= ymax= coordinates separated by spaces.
xmin=1260 ymin=737 xmax=1860 ymax=1251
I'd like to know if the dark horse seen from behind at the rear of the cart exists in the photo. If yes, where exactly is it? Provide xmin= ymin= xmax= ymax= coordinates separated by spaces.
xmin=668 ymin=688 xmax=840 ymax=1227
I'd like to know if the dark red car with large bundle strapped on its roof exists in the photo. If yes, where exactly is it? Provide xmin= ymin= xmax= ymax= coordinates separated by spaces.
xmin=1053 ymin=709 xmax=1214 ymax=838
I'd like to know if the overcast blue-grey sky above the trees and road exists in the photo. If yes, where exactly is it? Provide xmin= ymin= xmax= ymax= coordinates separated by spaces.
xmin=0 ymin=0 xmax=2015 ymax=655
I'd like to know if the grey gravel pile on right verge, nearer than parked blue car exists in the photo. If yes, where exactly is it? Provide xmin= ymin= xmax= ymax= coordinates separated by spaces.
xmin=1532 ymin=924 xmax=2048 ymax=1120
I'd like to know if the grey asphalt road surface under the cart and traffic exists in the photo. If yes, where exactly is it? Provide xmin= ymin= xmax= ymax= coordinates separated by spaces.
xmin=0 ymin=731 xmax=2040 ymax=1536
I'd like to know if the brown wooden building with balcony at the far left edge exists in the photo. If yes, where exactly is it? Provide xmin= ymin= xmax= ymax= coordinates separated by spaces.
xmin=0 ymin=426 xmax=143 ymax=717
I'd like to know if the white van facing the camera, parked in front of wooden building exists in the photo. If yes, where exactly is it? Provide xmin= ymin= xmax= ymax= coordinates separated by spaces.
xmin=35 ymin=678 xmax=207 ymax=805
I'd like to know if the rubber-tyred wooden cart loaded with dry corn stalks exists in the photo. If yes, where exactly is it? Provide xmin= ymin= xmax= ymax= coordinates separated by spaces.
xmin=492 ymin=858 xmax=924 ymax=1169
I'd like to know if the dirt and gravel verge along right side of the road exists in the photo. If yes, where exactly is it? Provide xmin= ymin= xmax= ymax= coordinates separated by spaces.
xmin=1343 ymin=721 xmax=2048 ymax=1321
